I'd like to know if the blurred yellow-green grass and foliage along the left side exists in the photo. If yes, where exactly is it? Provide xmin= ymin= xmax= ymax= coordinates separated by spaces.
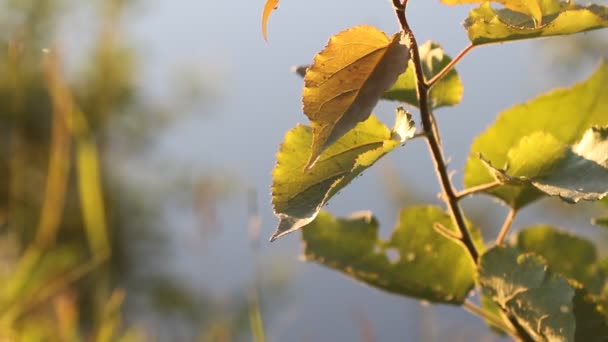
xmin=0 ymin=0 xmax=270 ymax=341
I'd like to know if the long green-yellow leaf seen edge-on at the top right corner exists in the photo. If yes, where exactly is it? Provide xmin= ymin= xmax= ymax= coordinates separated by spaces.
xmin=464 ymin=1 xmax=608 ymax=45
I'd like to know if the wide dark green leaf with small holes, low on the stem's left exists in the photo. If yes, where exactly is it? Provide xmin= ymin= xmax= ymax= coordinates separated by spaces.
xmin=302 ymin=207 xmax=483 ymax=304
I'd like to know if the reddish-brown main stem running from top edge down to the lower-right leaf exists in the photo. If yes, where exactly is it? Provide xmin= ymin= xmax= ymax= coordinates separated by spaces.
xmin=393 ymin=0 xmax=479 ymax=263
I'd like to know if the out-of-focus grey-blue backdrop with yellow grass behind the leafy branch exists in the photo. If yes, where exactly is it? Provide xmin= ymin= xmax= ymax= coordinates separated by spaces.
xmin=0 ymin=0 xmax=608 ymax=341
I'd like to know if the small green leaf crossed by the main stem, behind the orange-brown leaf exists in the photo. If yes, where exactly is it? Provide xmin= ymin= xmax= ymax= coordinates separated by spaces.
xmin=382 ymin=41 xmax=464 ymax=108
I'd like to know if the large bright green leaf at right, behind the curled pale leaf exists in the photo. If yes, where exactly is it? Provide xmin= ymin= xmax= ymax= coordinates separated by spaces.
xmin=464 ymin=63 xmax=608 ymax=209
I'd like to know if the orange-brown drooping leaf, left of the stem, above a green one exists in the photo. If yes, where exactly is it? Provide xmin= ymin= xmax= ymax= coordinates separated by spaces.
xmin=302 ymin=26 xmax=409 ymax=169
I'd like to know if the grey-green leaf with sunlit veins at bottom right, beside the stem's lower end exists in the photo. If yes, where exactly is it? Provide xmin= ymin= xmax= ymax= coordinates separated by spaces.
xmin=479 ymin=246 xmax=576 ymax=341
